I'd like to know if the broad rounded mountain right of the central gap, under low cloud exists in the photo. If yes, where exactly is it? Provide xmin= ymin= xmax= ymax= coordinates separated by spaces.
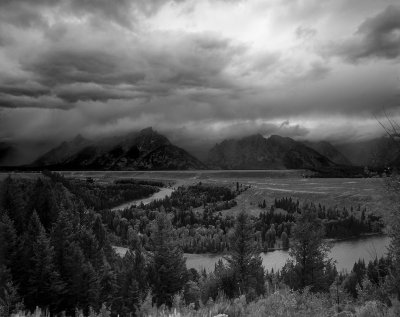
xmin=207 ymin=134 xmax=336 ymax=169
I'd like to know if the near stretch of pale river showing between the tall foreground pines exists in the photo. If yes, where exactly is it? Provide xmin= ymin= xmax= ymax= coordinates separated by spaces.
xmin=185 ymin=236 xmax=390 ymax=271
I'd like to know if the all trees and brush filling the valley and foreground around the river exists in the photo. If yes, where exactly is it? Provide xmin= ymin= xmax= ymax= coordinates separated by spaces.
xmin=0 ymin=174 xmax=400 ymax=316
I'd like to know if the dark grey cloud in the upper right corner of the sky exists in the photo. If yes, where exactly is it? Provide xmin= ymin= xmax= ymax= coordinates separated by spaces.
xmin=334 ymin=5 xmax=400 ymax=62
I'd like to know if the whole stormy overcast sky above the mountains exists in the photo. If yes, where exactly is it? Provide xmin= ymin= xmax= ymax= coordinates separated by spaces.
xmin=0 ymin=0 xmax=400 ymax=156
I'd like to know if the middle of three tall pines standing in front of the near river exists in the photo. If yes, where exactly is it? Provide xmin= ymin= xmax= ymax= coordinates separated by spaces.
xmin=226 ymin=210 xmax=264 ymax=295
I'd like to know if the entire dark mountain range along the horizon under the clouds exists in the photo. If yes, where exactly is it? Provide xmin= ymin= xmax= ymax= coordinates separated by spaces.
xmin=0 ymin=128 xmax=400 ymax=171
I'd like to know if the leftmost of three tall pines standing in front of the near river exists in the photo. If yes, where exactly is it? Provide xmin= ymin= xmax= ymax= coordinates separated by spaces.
xmin=150 ymin=212 xmax=187 ymax=307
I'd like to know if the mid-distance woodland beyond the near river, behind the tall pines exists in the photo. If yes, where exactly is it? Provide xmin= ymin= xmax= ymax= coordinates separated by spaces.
xmin=101 ymin=191 xmax=383 ymax=253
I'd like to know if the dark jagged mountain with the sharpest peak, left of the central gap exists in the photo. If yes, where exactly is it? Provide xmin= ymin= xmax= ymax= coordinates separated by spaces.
xmin=32 ymin=127 xmax=206 ymax=170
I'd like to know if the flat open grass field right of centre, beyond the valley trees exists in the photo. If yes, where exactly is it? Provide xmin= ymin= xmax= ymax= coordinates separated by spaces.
xmin=226 ymin=178 xmax=395 ymax=216
